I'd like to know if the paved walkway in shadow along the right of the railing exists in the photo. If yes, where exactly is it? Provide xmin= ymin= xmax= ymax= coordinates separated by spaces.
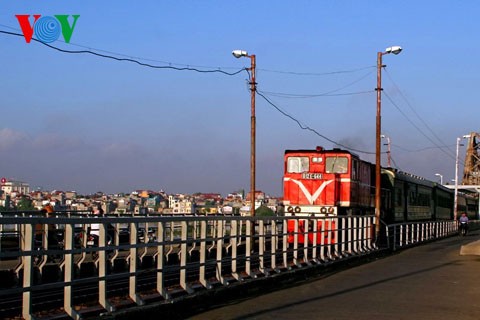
xmin=189 ymin=231 xmax=480 ymax=320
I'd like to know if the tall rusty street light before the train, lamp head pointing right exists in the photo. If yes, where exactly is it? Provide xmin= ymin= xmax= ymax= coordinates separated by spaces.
xmin=375 ymin=46 xmax=402 ymax=239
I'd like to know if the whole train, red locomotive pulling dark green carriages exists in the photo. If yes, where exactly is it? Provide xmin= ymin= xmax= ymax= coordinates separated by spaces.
xmin=283 ymin=147 xmax=478 ymax=241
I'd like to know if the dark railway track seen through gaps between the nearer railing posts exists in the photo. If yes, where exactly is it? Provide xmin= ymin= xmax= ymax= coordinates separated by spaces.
xmin=0 ymin=245 xmax=270 ymax=319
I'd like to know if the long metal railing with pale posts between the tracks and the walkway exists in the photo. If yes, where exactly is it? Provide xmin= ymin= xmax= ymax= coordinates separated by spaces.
xmin=0 ymin=212 xmax=474 ymax=319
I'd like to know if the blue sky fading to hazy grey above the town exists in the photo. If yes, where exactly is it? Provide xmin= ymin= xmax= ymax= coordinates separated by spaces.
xmin=0 ymin=0 xmax=480 ymax=196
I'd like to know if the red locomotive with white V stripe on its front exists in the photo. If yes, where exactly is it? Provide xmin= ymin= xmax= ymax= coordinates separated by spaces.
xmin=283 ymin=147 xmax=375 ymax=243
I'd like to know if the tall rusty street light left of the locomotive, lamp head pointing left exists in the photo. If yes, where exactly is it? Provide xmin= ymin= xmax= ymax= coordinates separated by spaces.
xmin=232 ymin=50 xmax=257 ymax=217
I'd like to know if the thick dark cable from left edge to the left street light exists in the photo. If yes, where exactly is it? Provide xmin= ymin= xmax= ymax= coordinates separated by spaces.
xmin=0 ymin=30 xmax=246 ymax=76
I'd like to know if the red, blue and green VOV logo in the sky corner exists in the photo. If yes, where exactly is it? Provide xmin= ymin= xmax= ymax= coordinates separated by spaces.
xmin=15 ymin=14 xmax=80 ymax=43
